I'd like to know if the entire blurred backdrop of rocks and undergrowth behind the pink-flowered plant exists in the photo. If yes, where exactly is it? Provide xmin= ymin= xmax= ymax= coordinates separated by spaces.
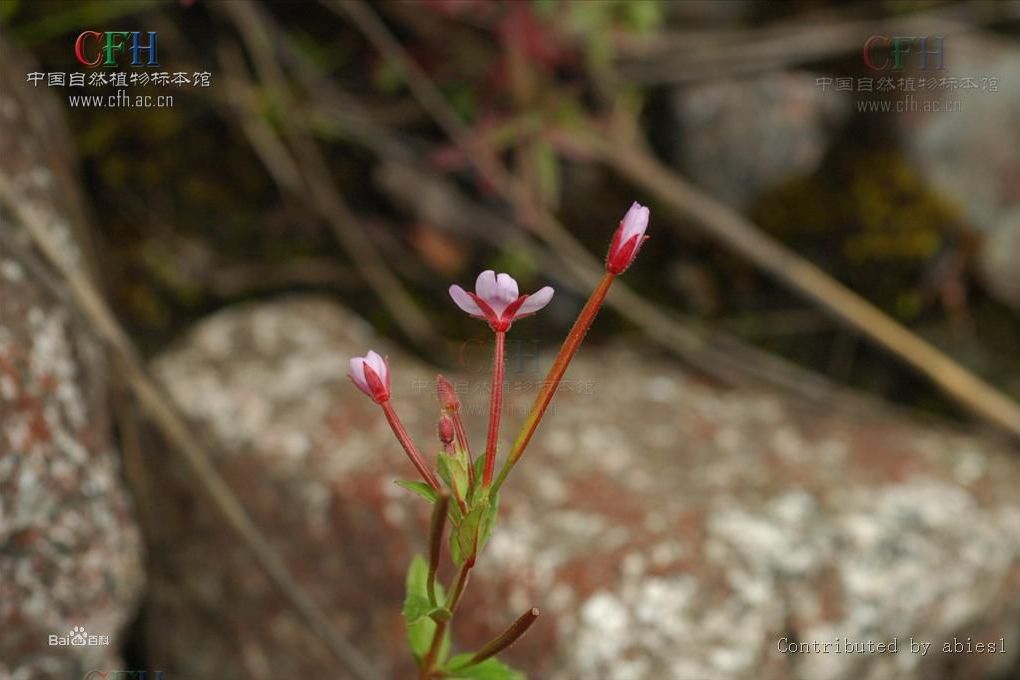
xmin=0 ymin=0 xmax=1020 ymax=680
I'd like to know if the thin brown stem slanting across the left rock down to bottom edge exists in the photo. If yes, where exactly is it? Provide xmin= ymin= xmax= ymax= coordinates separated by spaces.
xmin=0 ymin=176 xmax=379 ymax=680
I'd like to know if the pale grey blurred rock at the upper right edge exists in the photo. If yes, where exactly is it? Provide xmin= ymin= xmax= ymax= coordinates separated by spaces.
xmin=898 ymin=36 xmax=1020 ymax=310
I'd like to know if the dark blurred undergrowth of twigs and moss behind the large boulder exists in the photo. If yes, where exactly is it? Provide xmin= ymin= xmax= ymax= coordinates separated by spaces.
xmin=0 ymin=0 xmax=1020 ymax=420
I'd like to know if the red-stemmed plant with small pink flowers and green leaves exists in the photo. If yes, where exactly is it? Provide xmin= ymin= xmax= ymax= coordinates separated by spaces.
xmin=349 ymin=203 xmax=649 ymax=680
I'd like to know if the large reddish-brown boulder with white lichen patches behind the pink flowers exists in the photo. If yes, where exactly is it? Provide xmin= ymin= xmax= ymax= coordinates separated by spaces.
xmin=151 ymin=298 xmax=1020 ymax=680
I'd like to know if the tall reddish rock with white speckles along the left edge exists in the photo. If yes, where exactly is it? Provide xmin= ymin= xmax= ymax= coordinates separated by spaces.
xmin=0 ymin=35 xmax=144 ymax=680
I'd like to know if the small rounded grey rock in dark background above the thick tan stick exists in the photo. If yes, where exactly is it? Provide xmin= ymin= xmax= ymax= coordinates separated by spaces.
xmin=672 ymin=72 xmax=850 ymax=209
